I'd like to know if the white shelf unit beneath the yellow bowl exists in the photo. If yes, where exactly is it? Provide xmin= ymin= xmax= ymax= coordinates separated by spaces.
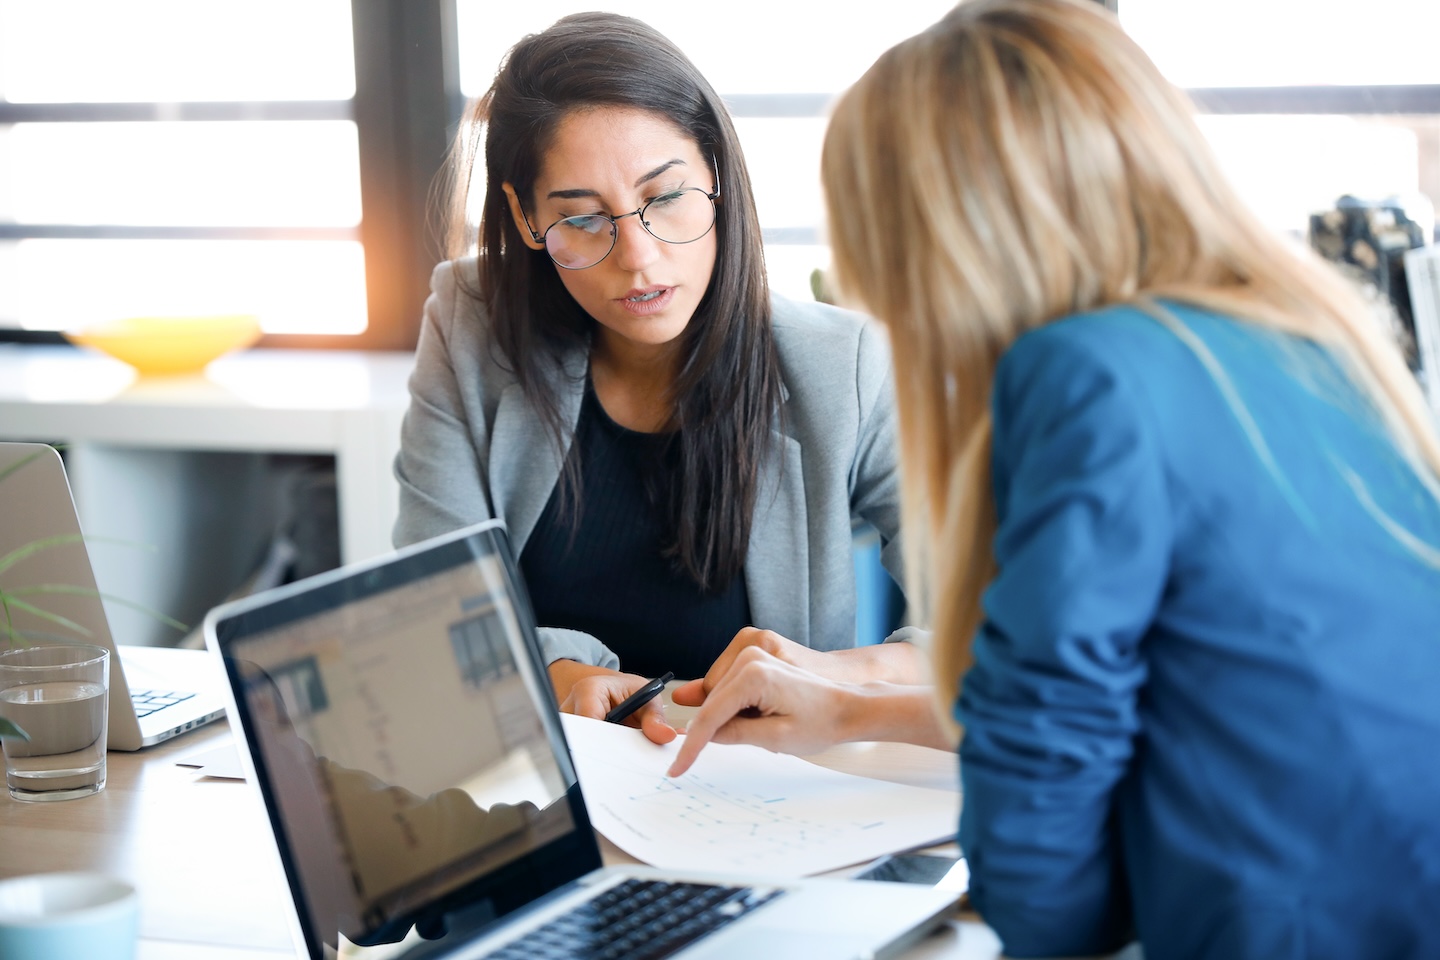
xmin=0 ymin=344 xmax=415 ymax=642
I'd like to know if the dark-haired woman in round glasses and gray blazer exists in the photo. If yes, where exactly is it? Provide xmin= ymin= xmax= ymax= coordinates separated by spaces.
xmin=395 ymin=14 xmax=920 ymax=741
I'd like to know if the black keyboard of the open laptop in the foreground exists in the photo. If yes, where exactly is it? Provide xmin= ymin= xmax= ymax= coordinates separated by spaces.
xmin=488 ymin=879 xmax=785 ymax=960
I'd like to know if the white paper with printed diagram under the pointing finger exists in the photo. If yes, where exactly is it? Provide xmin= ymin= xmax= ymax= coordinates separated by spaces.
xmin=562 ymin=714 xmax=960 ymax=877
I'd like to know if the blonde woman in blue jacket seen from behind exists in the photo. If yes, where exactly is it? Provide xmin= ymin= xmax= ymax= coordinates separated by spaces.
xmin=673 ymin=0 xmax=1440 ymax=960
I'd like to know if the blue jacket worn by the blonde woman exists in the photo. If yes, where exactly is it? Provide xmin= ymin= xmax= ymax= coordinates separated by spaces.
xmin=956 ymin=305 xmax=1440 ymax=960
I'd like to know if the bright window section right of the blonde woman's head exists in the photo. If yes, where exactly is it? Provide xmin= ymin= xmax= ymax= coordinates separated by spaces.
xmin=1119 ymin=0 xmax=1440 ymax=235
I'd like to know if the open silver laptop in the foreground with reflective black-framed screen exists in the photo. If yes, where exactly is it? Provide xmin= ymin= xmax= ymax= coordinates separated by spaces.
xmin=204 ymin=521 xmax=959 ymax=960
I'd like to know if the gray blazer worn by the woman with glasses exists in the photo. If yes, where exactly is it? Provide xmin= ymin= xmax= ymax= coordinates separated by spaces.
xmin=395 ymin=258 xmax=901 ymax=669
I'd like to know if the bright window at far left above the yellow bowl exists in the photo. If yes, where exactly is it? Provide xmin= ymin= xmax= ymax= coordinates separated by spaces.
xmin=0 ymin=0 xmax=458 ymax=347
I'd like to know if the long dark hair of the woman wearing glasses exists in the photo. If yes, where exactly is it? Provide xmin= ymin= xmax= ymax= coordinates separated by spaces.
xmin=449 ymin=13 xmax=780 ymax=590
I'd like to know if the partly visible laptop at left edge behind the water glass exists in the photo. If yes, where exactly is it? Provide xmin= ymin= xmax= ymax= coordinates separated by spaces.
xmin=0 ymin=442 xmax=225 ymax=750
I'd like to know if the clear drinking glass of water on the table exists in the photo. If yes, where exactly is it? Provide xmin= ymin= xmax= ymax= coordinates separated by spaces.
xmin=0 ymin=643 xmax=109 ymax=800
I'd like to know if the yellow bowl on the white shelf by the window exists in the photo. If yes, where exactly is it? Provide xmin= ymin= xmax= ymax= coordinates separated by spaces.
xmin=65 ymin=314 xmax=261 ymax=374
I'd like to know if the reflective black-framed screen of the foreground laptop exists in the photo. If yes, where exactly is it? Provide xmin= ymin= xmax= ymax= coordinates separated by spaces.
xmin=210 ymin=525 xmax=599 ymax=956
